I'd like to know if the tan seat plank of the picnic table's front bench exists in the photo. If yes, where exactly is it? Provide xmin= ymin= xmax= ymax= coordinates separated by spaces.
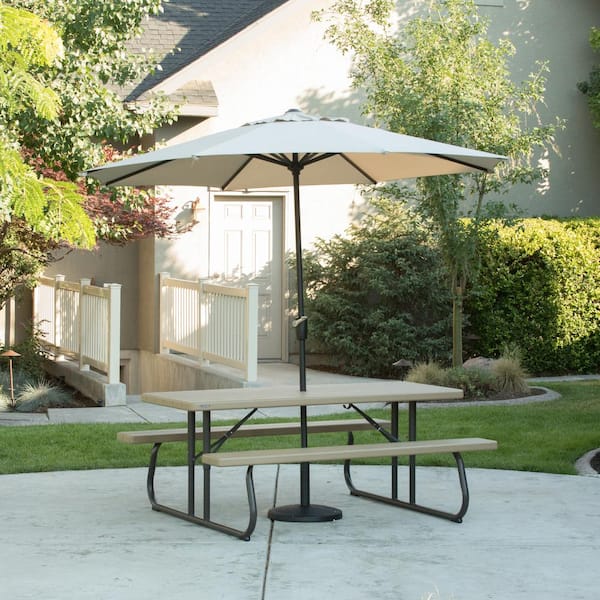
xmin=202 ymin=438 xmax=498 ymax=467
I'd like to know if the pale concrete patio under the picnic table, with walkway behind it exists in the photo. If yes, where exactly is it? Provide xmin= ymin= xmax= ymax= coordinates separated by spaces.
xmin=0 ymin=367 xmax=600 ymax=600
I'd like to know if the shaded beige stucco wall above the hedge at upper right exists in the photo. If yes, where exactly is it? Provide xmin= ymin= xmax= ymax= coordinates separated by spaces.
xmin=481 ymin=0 xmax=600 ymax=216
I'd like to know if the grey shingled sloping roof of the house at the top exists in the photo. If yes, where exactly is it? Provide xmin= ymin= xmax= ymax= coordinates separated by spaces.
xmin=122 ymin=0 xmax=288 ymax=105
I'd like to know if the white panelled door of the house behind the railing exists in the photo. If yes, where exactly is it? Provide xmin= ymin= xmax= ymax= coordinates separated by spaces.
xmin=209 ymin=196 xmax=283 ymax=360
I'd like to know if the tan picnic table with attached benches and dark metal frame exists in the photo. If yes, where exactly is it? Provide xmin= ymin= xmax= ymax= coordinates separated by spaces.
xmin=131 ymin=381 xmax=496 ymax=540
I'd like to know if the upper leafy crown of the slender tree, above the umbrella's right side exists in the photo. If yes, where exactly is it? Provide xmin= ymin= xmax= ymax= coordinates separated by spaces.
xmin=320 ymin=0 xmax=556 ymax=196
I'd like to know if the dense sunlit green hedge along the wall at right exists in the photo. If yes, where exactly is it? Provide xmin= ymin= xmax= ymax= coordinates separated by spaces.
xmin=466 ymin=219 xmax=600 ymax=374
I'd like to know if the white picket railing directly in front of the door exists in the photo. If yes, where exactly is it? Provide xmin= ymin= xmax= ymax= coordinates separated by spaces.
xmin=160 ymin=273 xmax=258 ymax=381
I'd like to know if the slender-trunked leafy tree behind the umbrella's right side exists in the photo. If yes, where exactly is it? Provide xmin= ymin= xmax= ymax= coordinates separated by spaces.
xmin=317 ymin=0 xmax=561 ymax=366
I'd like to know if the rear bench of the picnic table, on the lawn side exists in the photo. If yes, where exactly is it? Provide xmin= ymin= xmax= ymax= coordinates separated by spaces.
xmin=117 ymin=419 xmax=390 ymax=524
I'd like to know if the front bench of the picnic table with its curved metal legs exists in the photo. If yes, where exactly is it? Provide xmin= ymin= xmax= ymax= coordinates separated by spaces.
xmin=202 ymin=434 xmax=498 ymax=540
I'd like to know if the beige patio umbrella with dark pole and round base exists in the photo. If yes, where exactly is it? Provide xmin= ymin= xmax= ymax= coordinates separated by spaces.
xmin=85 ymin=110 xmax=504 ymax=521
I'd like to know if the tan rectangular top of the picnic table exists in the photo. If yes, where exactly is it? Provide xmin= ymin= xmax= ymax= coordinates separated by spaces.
xmin=142 ymin=381 xmax=463 ymax=412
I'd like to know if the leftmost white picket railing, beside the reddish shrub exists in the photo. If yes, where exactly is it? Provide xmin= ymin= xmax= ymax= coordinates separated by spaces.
xmin=33 ymin=275 xmax=121 ymax=383
